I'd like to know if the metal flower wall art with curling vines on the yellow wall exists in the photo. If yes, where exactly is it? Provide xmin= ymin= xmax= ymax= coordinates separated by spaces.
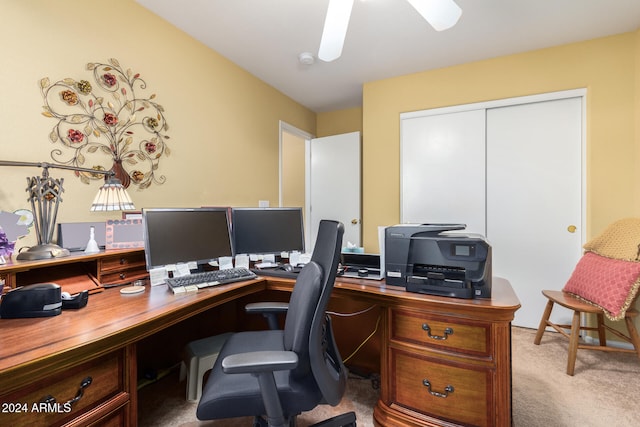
xmin=40 ymin=58 xmax=171 ymax=189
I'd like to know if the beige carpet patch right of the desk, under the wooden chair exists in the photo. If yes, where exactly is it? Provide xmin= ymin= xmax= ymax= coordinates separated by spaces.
xmin=512 ymin=328 xmax=640 ymax=427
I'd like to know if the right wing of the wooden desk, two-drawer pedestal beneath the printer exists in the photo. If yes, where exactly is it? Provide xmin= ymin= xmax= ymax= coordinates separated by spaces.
xmin=333 ymin=278 xmax=520 ymax=427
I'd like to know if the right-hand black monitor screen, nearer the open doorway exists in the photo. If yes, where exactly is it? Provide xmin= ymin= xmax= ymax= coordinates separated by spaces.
xmin=231 ymin=208 xmax=304 ymax=254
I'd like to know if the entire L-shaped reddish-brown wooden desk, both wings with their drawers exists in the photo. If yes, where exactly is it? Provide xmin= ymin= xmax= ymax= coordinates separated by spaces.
xmin=0 ymin=251 xmax=520 ymax=427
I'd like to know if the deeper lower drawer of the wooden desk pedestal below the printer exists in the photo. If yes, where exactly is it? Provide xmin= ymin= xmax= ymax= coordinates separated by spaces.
xmin=390 ymin=350 xmax=493 ymax=426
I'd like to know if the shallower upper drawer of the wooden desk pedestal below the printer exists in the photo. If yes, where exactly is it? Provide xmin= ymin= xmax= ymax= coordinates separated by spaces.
xmin=390 ymin=309 xmax=491 ymax=356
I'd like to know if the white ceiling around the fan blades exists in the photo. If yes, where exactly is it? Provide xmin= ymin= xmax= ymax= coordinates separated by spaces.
xmin=136 ymin=0 xmax=640 ymax=112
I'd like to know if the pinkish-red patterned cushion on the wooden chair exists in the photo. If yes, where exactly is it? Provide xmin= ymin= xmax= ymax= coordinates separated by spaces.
xmin=563 ymin=252 xmax=640 ymax=320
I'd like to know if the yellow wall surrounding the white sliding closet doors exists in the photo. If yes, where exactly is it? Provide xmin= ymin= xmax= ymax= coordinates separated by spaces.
xmin=363 ymin=32 xmax=640 ymax=249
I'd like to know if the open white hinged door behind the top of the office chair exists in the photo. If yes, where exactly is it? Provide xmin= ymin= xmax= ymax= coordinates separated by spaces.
xmin=309 ymin=132 xmax=361 ymax=248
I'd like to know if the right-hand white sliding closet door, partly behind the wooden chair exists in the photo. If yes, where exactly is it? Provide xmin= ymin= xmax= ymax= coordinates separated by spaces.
xmin=487 ymin=97 xmax=583 ymax=328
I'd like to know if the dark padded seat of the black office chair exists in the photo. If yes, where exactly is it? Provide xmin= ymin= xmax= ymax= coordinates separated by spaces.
xmin=196 ymin=330 xmax=322 ymax=420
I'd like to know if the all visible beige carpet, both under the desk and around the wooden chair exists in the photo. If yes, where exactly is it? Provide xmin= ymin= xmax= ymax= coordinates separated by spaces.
xmin=139 ymin=328 xmax=640 ymax=427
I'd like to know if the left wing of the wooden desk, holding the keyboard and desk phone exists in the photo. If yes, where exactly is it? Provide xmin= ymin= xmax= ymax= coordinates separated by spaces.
xmin=0 ymin=280 xmax=266 ymax=426
